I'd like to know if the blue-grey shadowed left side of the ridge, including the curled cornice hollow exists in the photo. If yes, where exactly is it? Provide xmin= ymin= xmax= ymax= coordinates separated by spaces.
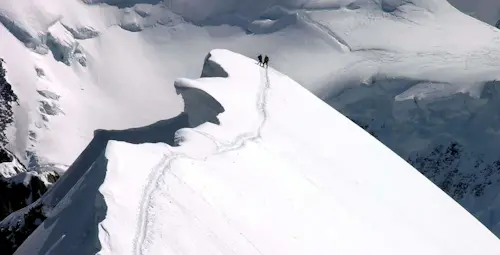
xmin=21 ymin=91 xmax=224 ymax=255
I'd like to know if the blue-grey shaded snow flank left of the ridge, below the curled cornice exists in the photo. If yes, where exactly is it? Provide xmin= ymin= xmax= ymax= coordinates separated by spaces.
xmin=8 ymin=114 xmax=193 ymax=254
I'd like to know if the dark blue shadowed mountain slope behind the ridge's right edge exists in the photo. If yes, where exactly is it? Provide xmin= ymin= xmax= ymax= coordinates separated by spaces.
xmin=329 ymin=79 xmax=500 ymax=235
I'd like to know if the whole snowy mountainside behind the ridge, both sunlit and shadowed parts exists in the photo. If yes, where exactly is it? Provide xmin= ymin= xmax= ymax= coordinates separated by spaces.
xmin=0 ymin=0 xmax=500 ymax=247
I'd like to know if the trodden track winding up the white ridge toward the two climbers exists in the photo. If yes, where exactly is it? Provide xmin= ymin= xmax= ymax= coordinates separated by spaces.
xmin=133 ymin=68 xmax=271 ymax=255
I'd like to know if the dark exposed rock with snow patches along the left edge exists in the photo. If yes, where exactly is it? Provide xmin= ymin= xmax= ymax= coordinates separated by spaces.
xmin=0 ymin=59 xmax=59 ymax=254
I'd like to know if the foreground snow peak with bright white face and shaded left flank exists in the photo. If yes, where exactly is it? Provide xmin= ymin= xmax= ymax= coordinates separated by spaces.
xmin=15 ymin=50 xmax=500 ymax=255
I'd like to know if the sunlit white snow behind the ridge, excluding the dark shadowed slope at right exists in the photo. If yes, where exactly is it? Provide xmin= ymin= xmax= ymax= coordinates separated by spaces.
xmin=0 ymin=0 xmax=500 ymax=169
